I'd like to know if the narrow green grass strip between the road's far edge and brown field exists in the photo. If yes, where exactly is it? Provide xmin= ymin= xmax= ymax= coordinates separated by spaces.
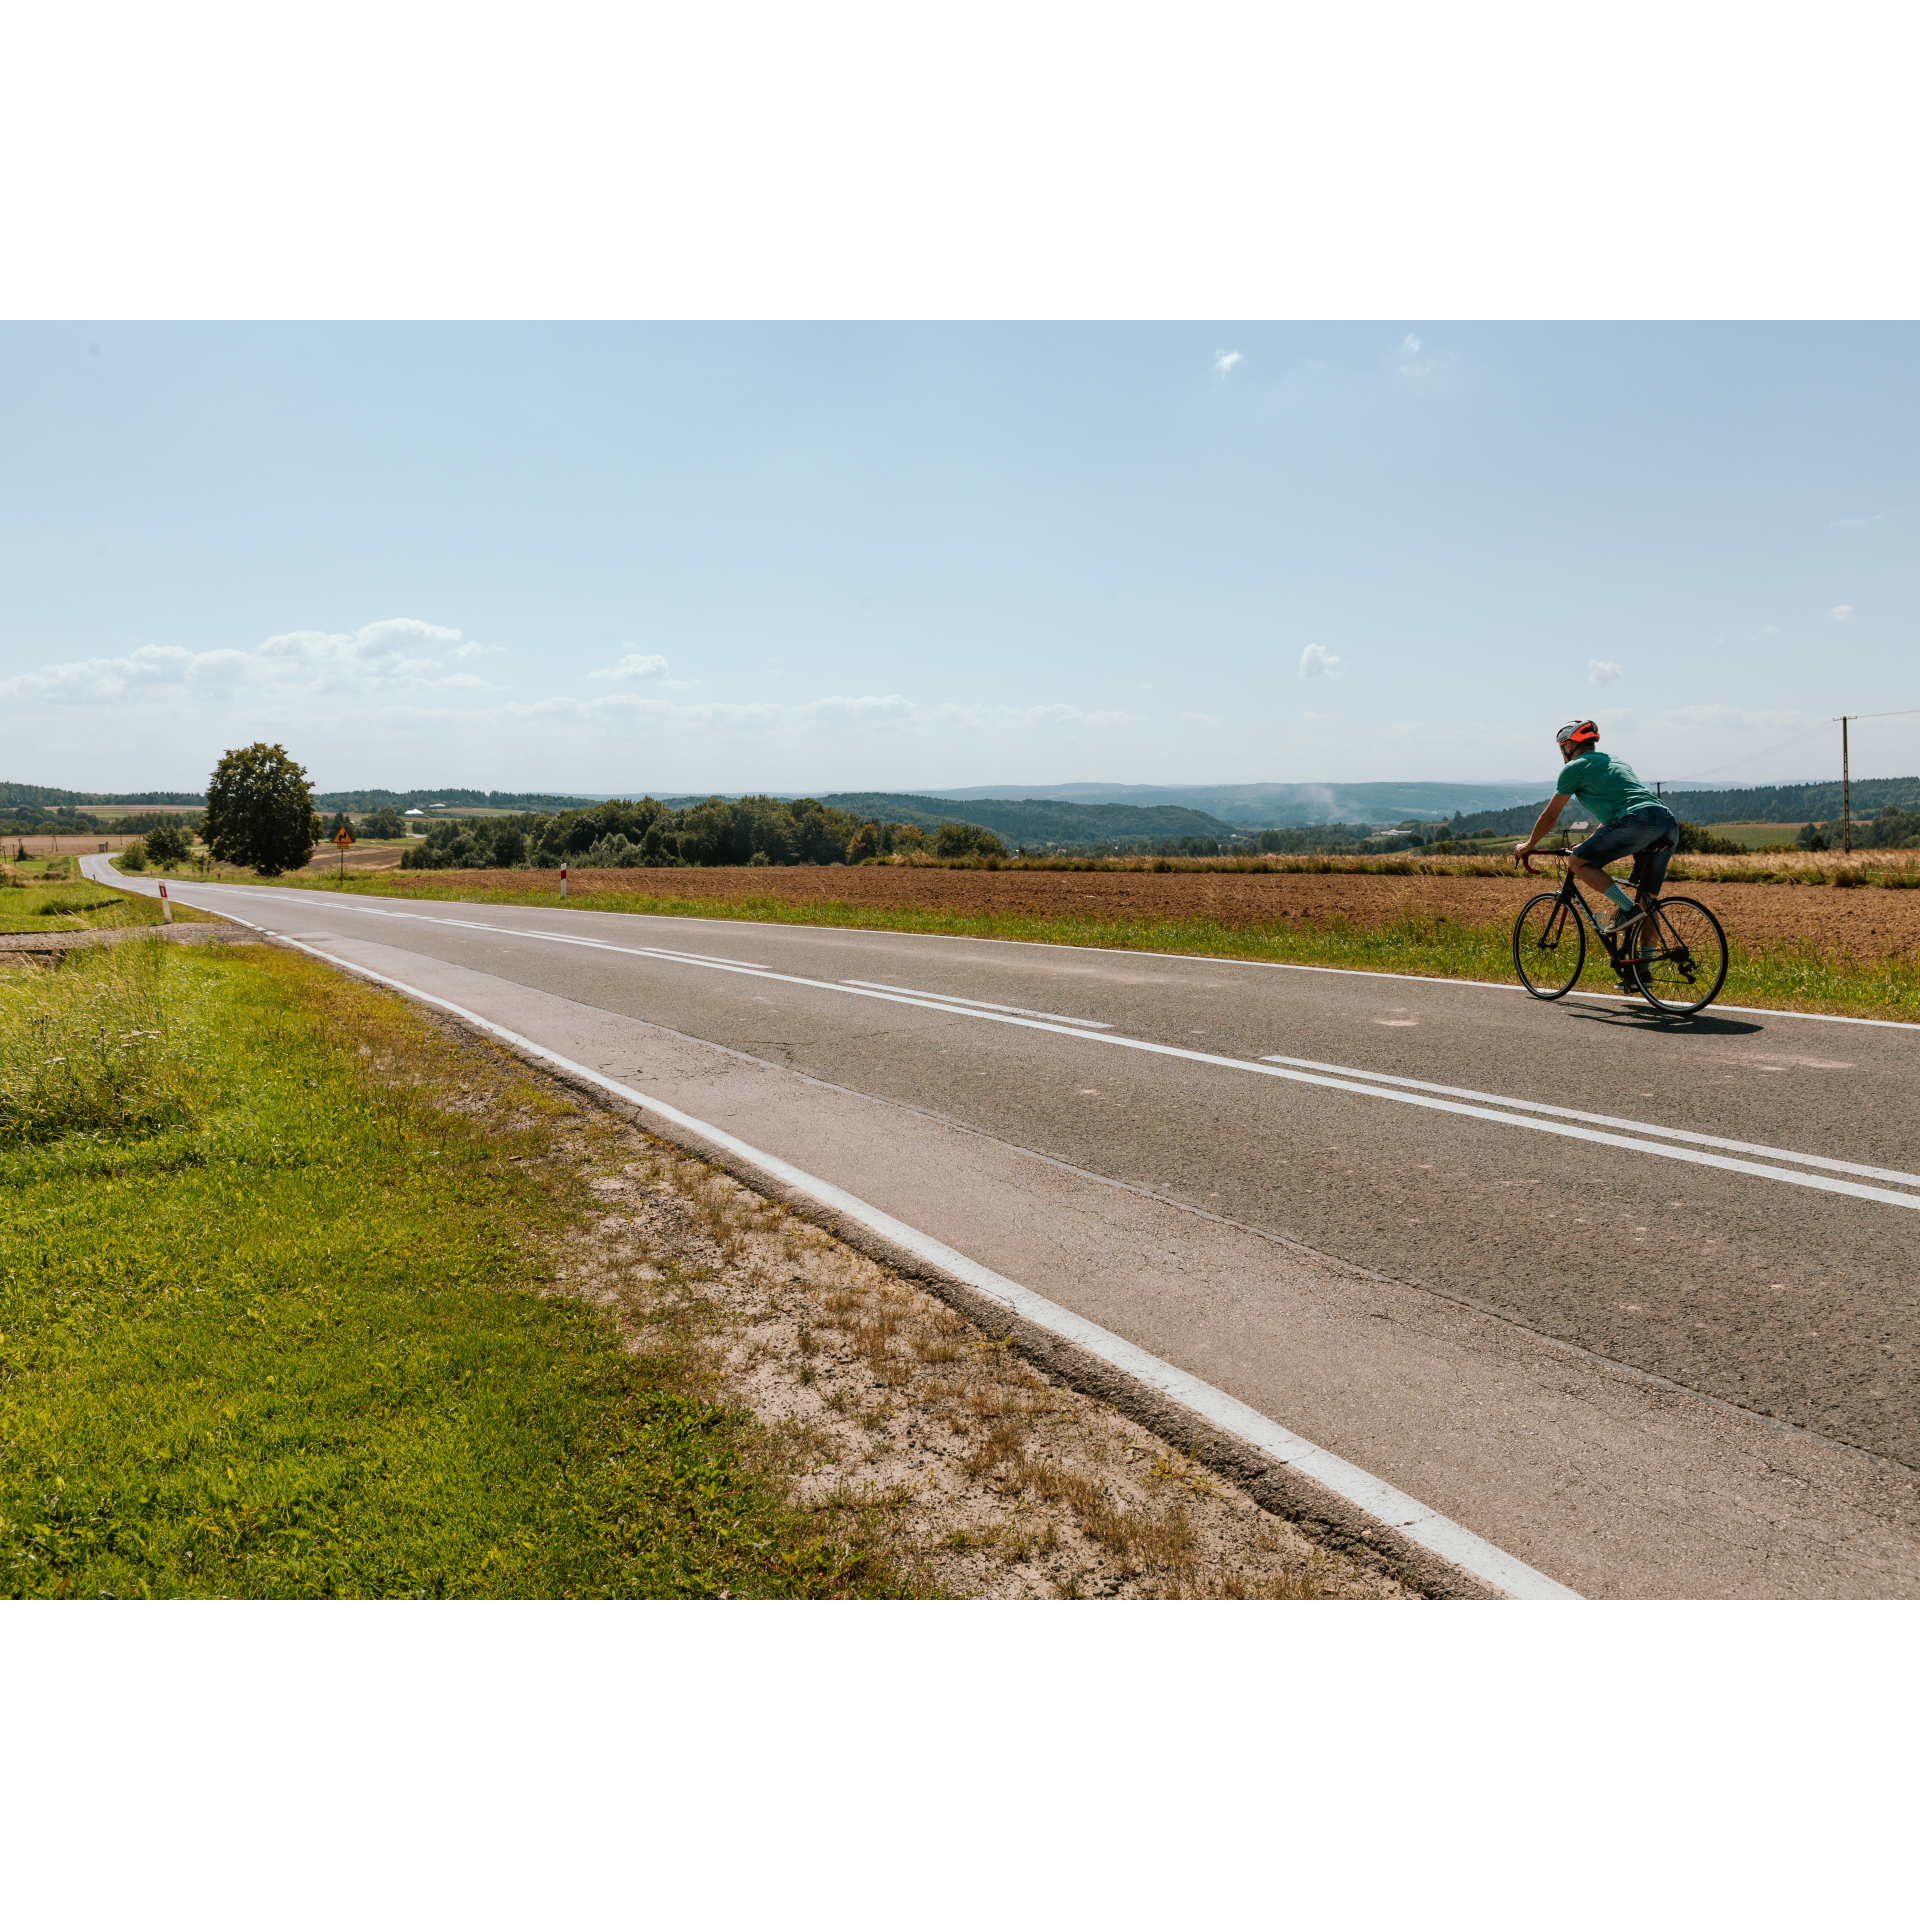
xmin=198 ymin=874 xmax=1920 ymax=1021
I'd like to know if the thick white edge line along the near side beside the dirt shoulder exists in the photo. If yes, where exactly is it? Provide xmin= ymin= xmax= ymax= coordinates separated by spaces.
xmin=243 ymin=914 xmax=1582 ymax=1599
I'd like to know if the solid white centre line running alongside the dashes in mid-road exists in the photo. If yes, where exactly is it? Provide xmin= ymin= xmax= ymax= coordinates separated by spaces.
xmin=108 ymin=871 xmax=1920 ymax=1212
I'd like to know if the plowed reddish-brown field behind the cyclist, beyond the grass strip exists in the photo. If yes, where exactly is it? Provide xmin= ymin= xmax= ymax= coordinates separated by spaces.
xmin=349 ymin=866 xmax=1920 ymax=960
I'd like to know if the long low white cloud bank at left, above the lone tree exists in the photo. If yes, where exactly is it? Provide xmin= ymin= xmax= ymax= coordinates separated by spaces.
xmin=0 ymin=620 xmax=503 ymax=707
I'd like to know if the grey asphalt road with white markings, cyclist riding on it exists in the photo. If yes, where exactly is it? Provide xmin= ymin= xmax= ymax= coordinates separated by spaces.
xmin=88 ymin=862 xmax=1920 ymax=1594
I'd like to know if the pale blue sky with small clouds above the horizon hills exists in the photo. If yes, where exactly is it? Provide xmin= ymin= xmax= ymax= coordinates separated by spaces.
xmin=0 ymin=319 xmax=1920 ymax=791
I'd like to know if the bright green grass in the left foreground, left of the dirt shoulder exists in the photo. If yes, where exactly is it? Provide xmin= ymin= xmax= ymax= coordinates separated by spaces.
xmin=0 ymin=943 xmax=913 ymax=1597
